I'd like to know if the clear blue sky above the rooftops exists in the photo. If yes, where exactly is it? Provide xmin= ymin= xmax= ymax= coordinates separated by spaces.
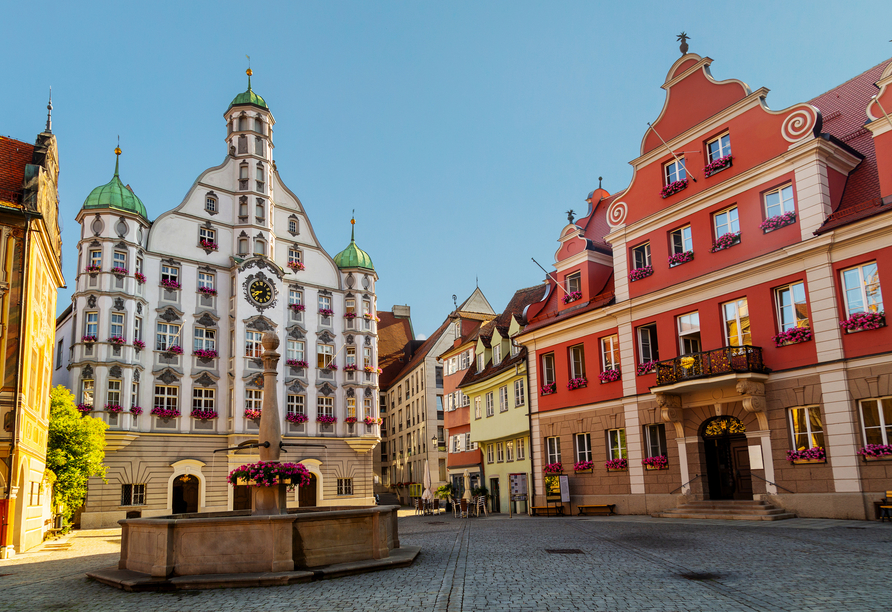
xmin=0 ymin=0 xmax=892 ymax=335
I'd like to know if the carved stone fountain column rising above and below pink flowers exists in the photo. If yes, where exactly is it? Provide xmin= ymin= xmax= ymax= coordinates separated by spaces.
xmin=251 ymin=331 xmax=288 ymax=515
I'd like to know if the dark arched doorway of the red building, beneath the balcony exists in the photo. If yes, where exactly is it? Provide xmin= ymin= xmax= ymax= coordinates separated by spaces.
xmin=700 ymin=415 xmax=753 ymax=500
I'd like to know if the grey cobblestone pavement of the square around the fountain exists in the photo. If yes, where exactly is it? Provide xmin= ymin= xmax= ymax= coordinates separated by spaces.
xmin=0 ymin=514 xmax=892 ymax=612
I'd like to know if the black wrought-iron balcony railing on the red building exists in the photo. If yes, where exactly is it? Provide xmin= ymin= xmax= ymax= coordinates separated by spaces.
xmin=656 ymin=346 xmax=770 ymax=387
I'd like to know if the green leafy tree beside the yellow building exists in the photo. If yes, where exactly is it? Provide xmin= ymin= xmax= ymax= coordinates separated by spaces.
xmin=46 ymin=385 xmax=108 ymax=521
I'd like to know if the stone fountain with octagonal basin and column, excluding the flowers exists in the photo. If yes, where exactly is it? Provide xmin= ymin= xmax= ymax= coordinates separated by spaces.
xmin=87 ymin=331 xmax=420 ymax=591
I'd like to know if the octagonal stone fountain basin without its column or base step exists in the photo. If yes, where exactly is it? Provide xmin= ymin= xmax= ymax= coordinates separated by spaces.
xmin=118 ymin=506 xmax=399 ymax=578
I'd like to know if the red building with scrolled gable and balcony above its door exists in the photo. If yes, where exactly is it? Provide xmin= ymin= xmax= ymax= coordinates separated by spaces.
xmin=518 ymin=47 xmax=892 ymax=519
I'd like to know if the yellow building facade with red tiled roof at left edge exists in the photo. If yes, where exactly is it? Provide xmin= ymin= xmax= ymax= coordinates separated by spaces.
xmin=0 ymin=120 xmax=64 ymax=558
